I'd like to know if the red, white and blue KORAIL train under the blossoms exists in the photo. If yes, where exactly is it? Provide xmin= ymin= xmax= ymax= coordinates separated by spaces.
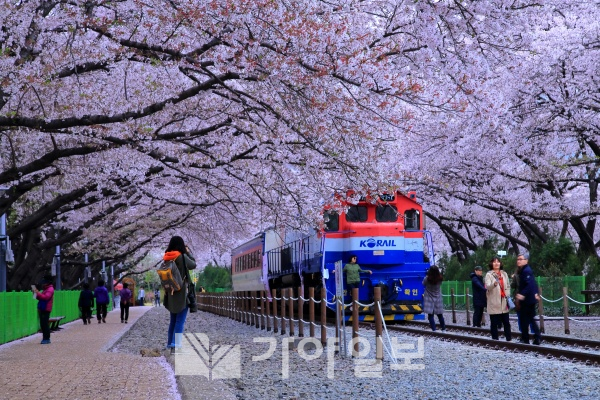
xmin=231 ymin=190 xmax=435 ymax=321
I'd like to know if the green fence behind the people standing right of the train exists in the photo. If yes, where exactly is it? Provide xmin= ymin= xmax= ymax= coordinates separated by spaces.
xmin=442 ymin=276 xmax=585 ymax=311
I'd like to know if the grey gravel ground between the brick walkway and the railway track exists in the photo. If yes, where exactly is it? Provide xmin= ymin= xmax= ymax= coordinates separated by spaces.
xmin=111 ymin=307 xmax=600 ymax=400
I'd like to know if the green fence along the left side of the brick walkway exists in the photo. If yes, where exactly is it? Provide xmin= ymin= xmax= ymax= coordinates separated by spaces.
xmin=0 ymin=290 xmax=112 ymax=344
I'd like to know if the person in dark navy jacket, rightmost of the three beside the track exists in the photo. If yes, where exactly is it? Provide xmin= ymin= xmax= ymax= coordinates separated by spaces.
xmin=516 ymin=253 xmax=542 ymax=345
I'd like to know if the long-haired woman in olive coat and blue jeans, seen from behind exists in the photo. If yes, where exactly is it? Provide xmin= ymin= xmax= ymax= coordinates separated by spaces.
xmin=163 ymin=236 xmax=196 ymax=353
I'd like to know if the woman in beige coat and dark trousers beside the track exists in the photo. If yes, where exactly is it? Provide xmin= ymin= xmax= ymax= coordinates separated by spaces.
xmin=485 ymin=257 xmax=512 ymax=342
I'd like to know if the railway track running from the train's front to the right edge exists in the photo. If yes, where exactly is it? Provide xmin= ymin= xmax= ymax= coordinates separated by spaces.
xmin=360 ymin=322 xmax=600 ymax=367
